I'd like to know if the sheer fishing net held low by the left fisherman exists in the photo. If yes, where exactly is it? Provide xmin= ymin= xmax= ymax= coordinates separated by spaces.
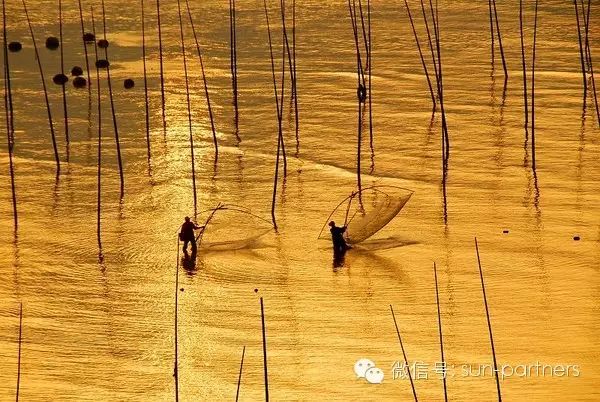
xmin=196 ymin=204 xmax=273 ymax=251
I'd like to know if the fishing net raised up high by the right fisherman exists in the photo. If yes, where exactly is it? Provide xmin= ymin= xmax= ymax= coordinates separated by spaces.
xmin=319 ymin=186 xmax=413 ymax=244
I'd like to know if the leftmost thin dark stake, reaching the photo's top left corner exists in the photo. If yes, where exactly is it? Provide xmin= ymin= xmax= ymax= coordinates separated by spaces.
xmin=2 ymin=0 xmax=19 ymax=231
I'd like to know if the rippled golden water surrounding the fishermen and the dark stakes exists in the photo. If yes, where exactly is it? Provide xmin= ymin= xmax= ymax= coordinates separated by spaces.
xmin=0 ymin=0 xmax=600 ymax=401
